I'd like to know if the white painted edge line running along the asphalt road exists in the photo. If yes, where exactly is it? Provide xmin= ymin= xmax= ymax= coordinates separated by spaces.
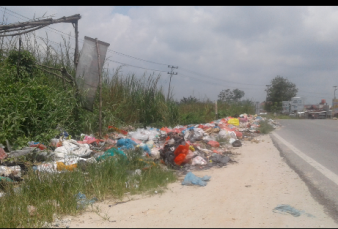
xmin=271 ymin=132 xmax=338 ymax=185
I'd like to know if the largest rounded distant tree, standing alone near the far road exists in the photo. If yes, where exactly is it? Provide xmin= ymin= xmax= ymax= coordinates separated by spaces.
xmin=265 ymin=76 xmax=298 ymax=111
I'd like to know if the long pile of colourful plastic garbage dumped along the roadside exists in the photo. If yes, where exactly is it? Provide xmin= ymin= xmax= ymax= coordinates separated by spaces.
xmin=0 ymin=114 xmax=279 ymax=181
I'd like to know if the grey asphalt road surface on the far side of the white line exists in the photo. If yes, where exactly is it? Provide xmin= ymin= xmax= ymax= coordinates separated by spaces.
xmin=276 ymin=119 xmax=338 ymax=175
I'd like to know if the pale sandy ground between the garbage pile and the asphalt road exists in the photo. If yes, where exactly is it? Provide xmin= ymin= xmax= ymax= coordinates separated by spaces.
xmin=61 ymin=135 xmax=338 ymax=228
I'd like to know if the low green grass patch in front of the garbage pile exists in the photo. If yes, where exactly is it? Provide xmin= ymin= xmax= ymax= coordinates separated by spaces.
xmin=0 ymin=151 xmax=176 ymax=228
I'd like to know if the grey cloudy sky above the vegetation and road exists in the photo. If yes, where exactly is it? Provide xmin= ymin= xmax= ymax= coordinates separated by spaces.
xmin=0 ymin=6 xmax=338 ymax=105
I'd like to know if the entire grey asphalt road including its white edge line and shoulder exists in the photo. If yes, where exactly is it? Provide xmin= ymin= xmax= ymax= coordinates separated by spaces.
xmin=270 ymin=119 xmax=338 ymax=223
